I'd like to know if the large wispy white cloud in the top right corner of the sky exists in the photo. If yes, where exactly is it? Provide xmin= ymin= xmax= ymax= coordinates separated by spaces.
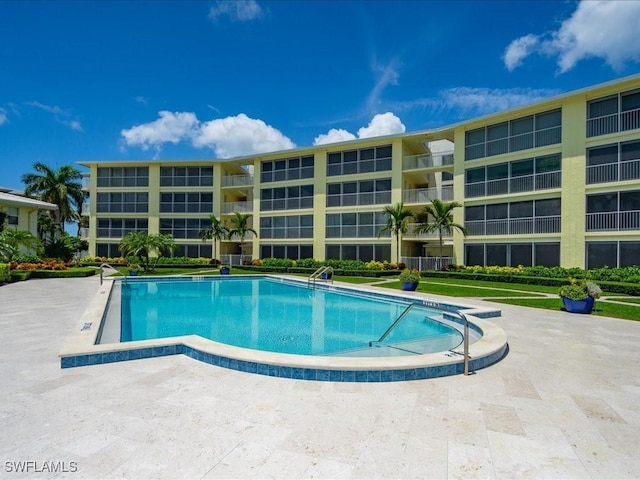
xmin=503 ymin=0 xmax=640 ymax=73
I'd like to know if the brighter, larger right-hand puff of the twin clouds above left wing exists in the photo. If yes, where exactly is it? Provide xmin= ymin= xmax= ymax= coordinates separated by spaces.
xmin=193 ymin=113 xmax=295 ymax=158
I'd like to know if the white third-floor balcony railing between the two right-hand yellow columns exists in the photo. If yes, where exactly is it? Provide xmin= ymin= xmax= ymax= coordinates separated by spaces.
xmin=464 ymin=170 xmax=562 ymax=198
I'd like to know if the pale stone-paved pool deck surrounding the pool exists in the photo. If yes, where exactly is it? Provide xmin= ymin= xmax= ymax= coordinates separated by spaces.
xmin=0 ymin=277 xmax=640 ymax=479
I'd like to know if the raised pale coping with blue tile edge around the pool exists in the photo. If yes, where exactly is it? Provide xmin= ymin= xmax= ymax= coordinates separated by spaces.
xmin=59 ymin=275 xmax=508 ymax=382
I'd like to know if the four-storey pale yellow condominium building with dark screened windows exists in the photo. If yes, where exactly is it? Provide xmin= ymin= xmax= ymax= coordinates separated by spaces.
xmin=80 ymin=75 xmax=640 ymax=268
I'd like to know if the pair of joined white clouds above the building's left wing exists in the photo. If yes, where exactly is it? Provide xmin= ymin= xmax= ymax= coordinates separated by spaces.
xmin=120 ymin=111 xmax=295 ymax=158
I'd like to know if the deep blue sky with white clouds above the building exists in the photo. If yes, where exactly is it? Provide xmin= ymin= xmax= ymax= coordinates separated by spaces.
xmin=0 ymin=0 xmax=640 ymax=189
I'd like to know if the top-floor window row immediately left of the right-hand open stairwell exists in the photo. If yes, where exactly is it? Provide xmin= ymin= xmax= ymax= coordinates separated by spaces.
xmin=327 ymin=145 xmax=392 ymax=177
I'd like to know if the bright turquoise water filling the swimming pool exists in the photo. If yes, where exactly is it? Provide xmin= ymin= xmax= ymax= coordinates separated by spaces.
xmin=120 ymin=277 xmax=462 ymax=355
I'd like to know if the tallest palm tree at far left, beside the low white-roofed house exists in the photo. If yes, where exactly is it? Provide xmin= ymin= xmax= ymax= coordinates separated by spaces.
xmin=22 ymin=162 xmax=85 ymax=231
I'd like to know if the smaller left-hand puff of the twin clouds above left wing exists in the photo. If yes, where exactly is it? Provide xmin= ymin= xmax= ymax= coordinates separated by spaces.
xmin=120 ymin=110 xmax=198 ymax=150
